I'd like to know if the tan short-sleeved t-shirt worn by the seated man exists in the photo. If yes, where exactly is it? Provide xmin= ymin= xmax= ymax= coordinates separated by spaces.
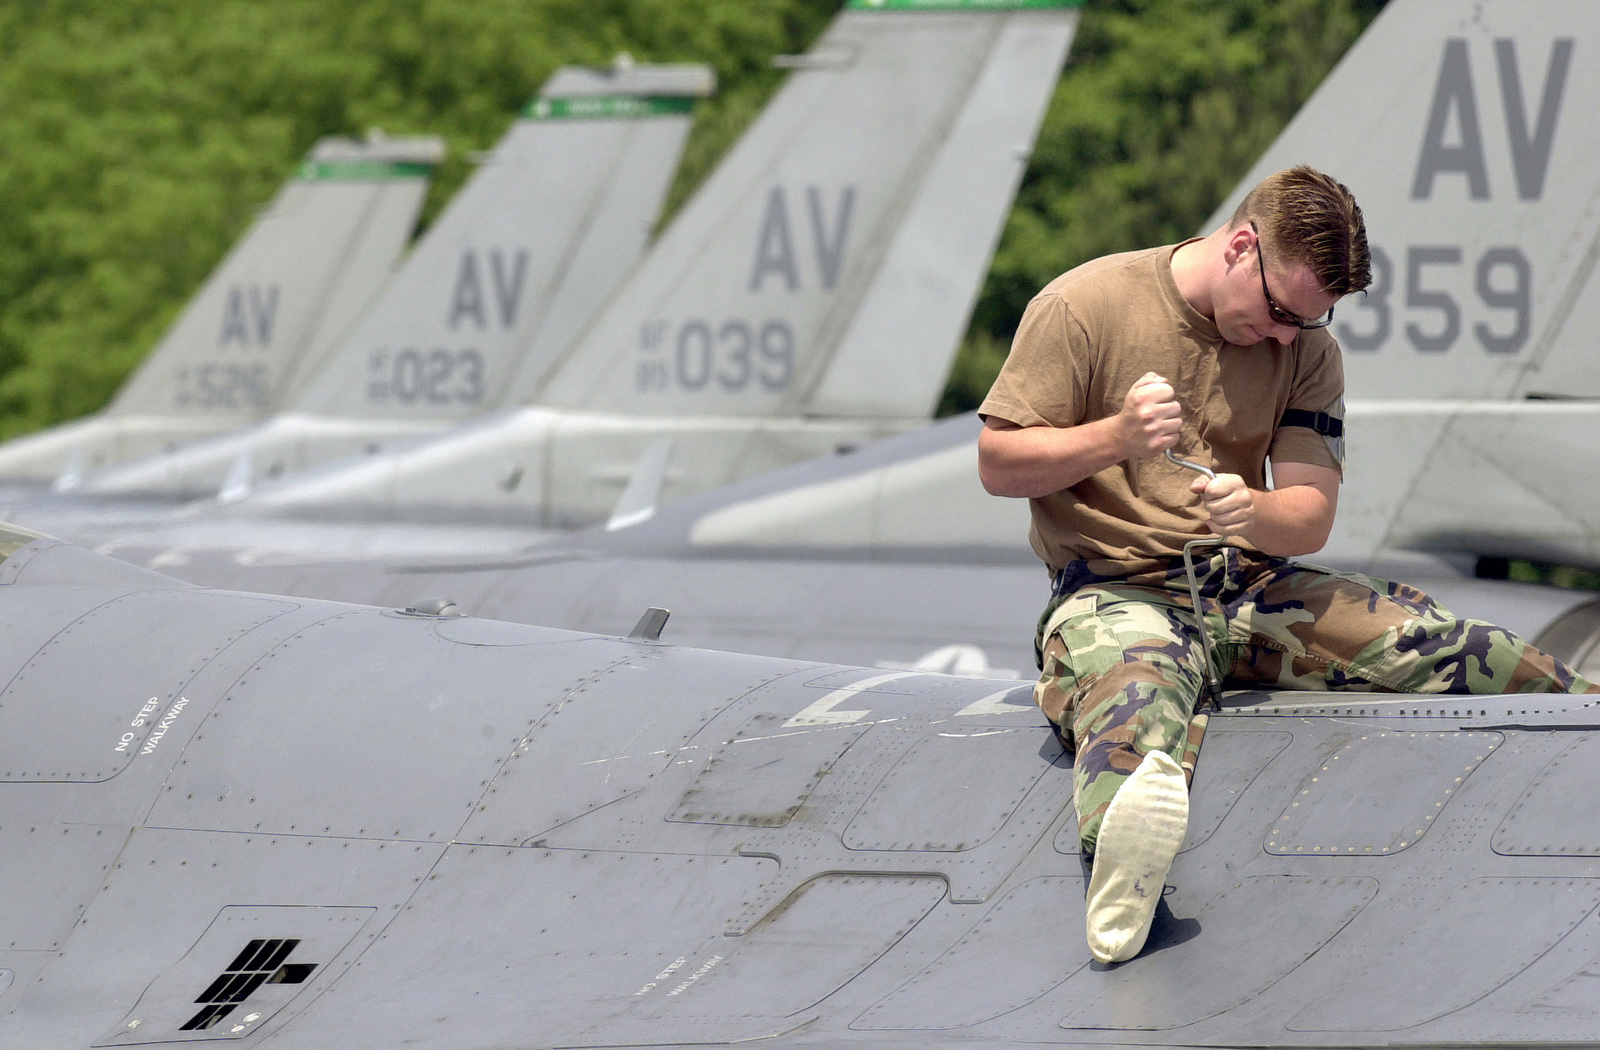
xmin=978 ymin=245 xmax=1344 ymax=570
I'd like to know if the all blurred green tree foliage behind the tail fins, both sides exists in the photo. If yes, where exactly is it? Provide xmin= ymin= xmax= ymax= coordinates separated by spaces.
xmin=0 ymin=0 xmax=1381 ymax=437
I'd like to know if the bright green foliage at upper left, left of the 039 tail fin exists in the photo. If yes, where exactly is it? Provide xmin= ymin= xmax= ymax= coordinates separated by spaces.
xmin=0 ymin=0 xmax=842 ymax=437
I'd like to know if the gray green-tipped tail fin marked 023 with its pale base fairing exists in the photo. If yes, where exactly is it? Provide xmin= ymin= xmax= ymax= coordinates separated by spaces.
xmin=75 ymin=61 xmax=714 ymax=498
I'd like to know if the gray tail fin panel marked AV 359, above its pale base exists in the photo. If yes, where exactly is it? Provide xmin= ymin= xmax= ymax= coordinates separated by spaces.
xmin=1203 ymin=0 xmax=1600 ymax=400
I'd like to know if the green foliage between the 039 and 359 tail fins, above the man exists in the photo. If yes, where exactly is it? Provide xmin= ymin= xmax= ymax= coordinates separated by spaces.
xmin=941 ymin=0 xmax=1382 ymax=415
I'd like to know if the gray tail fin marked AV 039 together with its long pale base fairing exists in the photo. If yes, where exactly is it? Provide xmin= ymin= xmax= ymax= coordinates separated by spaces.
xmin=203 ymin=0 xmax=1078 ymax=527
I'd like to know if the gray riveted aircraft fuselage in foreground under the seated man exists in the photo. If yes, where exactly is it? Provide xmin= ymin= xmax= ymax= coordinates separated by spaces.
xmin=9 ymin=535 xmax=1600 ymax=1050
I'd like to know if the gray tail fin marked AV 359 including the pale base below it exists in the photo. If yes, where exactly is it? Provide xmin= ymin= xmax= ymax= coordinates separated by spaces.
xmin=1184 ymin=0 xmax=1600 ymax=568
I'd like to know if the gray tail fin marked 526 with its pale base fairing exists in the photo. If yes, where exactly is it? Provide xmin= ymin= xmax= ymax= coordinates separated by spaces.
xmin=0 ymin=136 xmax=443 ymax=488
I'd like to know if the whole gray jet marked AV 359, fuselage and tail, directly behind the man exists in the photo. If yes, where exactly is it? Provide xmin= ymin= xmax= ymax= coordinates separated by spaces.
xmin=62 ymin=0 xmax=1600 ymax=672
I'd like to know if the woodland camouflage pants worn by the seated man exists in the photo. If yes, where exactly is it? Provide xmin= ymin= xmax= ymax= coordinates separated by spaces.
xmin=1034 ymin=547 xmax=1600 ymax=853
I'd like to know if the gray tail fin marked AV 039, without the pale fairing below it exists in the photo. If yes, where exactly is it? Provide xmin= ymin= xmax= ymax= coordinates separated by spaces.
xmin=531 ymin=0 xmax=1078 ymax=421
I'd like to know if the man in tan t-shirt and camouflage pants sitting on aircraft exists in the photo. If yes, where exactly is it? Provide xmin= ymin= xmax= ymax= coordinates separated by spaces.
xmin=978 ymin=165 xmax=1600 ymax=962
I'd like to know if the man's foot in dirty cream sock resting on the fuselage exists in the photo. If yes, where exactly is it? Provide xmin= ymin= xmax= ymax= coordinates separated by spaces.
xmin=1086 ymin=751 xmax=1189 ymax=962
